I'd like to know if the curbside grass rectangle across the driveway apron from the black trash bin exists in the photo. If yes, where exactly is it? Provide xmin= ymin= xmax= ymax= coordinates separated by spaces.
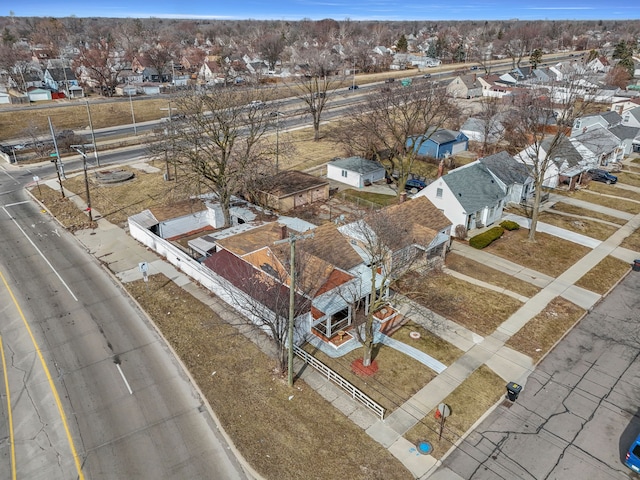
xmin=506 ymin=297 xmax=585 ymax=362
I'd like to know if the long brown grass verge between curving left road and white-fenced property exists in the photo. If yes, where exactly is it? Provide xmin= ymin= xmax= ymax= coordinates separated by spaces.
xmin=125 ymin=275 xmax=412 ymax=480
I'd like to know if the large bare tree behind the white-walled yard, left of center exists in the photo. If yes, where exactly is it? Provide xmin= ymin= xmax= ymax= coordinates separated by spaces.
xmin=172 ymin=89 xmax=270 ymax=227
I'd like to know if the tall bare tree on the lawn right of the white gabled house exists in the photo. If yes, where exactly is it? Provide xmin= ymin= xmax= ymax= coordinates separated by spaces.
xmin=505 ymin=72 xmax=598 ymax=242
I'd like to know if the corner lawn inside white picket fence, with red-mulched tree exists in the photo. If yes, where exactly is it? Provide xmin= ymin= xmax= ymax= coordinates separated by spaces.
xmin=304 ymin=344 xmax=436 ymax=415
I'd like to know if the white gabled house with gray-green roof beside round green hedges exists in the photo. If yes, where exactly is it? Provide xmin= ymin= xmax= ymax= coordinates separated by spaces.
xmin=414 ymin=160 xmax=507 ymax=230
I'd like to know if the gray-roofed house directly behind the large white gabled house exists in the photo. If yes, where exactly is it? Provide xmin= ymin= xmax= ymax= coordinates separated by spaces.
xmin=479 ymin=150 xmax=533 ymax=203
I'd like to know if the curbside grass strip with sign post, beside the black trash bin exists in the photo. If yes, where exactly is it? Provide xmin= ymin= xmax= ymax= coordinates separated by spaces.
xmin=405 ymin=365 xmax=506 ymax=458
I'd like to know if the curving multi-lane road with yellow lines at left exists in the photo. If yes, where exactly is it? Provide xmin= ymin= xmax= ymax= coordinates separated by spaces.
xmin=0 ymin=167 xmax=246 ymax=480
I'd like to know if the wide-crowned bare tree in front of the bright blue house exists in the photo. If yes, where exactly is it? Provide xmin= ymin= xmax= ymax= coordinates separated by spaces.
xmin=334 ymin=82 xmax=458 ymax=195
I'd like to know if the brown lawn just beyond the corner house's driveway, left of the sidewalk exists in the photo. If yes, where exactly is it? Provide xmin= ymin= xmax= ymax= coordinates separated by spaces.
xmin=396 ymin=272 xmax=522 ymax=335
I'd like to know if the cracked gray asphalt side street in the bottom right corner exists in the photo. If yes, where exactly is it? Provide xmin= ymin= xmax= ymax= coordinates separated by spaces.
xmin=430 ymin=271 xmax=640 ymax=480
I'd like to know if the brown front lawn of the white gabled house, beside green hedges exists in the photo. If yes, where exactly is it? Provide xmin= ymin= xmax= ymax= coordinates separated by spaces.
xmin=484 ymin=228 xmax=591 ymax=277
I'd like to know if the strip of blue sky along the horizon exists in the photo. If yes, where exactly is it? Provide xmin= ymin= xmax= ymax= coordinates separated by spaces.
xmin=6 ymin=0 xmax=640 ymax=21
